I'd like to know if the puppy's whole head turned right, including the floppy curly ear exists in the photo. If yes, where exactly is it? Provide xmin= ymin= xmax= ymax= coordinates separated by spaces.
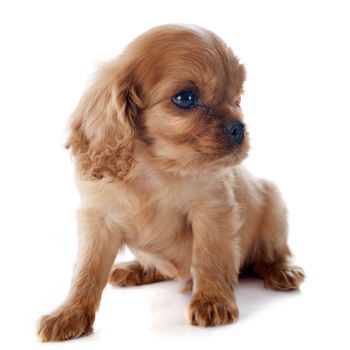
xmin=67 ymin=25 xmax=249 ymax=179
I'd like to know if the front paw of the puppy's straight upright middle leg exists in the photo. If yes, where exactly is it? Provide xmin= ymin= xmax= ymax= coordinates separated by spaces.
xmin=187 ymin=297 xmax=239 ymax=327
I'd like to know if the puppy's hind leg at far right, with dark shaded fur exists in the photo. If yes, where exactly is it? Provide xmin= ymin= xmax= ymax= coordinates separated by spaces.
xmin=252 ymin=181 xmax=305 ymax=291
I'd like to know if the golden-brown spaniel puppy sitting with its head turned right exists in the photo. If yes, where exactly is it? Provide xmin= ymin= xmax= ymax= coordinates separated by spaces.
xmin=38 ymin=25 xmax=304 ymax=341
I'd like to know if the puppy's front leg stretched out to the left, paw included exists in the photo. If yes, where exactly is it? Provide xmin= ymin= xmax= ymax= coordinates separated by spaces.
xmin=38 ymin=209 xmax=121 ymax=341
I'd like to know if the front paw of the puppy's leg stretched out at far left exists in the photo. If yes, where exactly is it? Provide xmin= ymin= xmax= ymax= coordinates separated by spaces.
xmin=38 ymin=305 xmax=95 ymax=341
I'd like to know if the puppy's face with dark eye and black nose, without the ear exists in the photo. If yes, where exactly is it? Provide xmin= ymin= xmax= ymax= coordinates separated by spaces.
xmin=132 ymin=27 xmax=249 ymax=171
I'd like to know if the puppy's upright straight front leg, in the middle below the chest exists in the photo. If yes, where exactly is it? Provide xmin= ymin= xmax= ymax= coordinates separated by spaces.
xmin=188 ymin=203 xmax=239 ymax=327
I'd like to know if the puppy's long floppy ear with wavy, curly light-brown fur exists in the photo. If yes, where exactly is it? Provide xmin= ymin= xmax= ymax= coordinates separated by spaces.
xmin=66 ymin=61 xmax=141 ymax=180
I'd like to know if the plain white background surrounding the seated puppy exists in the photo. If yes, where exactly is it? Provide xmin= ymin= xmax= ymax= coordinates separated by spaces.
xmin=0 ymin=0 xmax=350 ymax=349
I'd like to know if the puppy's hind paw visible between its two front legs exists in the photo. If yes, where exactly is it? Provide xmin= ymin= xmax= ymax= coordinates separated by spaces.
xmin=109 ymin=260 xmax=172 ymax=287
